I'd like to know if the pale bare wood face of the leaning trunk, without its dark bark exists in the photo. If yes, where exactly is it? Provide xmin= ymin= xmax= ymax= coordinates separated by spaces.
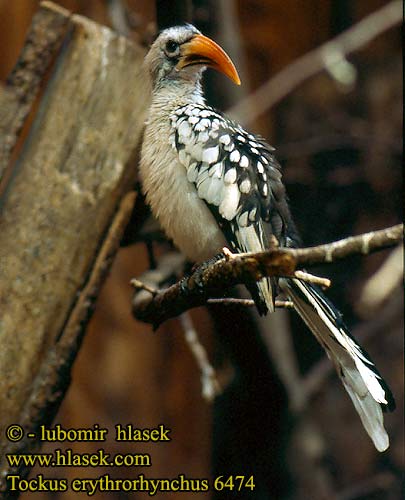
xmin=0 ymin=0 xmax=149 ymax=478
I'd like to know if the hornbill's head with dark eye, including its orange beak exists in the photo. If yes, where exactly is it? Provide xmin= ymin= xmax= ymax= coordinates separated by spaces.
xmin=145 ymin=24 xmax=240 ymax=89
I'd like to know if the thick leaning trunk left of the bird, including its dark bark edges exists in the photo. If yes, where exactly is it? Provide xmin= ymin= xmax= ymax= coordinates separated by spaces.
xmin=0 ymin=2 xmax=149 ymax=490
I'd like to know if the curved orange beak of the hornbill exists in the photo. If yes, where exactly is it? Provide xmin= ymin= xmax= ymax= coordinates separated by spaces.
xmin=177 ymin=35 xmax=240 ymax=85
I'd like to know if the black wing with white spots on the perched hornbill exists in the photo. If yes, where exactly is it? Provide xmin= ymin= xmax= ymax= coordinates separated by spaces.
xmin=171 ymin=104 xmax=291 ymax=313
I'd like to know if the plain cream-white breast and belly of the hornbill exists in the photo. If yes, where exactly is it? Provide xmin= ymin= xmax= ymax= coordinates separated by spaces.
xmin=140 ymin=120 xmax=226 ymax=262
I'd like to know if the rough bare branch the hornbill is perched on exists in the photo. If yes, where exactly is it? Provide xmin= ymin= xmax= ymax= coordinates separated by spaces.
xmin=133 ymin=224 xmax=403 ymax=328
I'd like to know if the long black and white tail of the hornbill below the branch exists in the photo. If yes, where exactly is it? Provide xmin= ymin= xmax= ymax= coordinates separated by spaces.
xmin=280 ymin=279 xmax=395 ymax=451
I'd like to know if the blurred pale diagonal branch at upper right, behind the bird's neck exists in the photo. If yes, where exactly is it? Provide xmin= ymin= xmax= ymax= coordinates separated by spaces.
xmin=227 ymin=0 xmax=402 ymax=124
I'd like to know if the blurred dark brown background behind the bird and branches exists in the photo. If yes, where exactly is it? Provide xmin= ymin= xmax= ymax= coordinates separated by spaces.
xmin=0 ymin=0 xmax=404 ymax=500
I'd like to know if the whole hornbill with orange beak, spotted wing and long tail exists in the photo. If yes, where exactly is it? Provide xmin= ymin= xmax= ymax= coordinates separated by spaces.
xmin=139 ymin=24 xmax=395 ymax=452
